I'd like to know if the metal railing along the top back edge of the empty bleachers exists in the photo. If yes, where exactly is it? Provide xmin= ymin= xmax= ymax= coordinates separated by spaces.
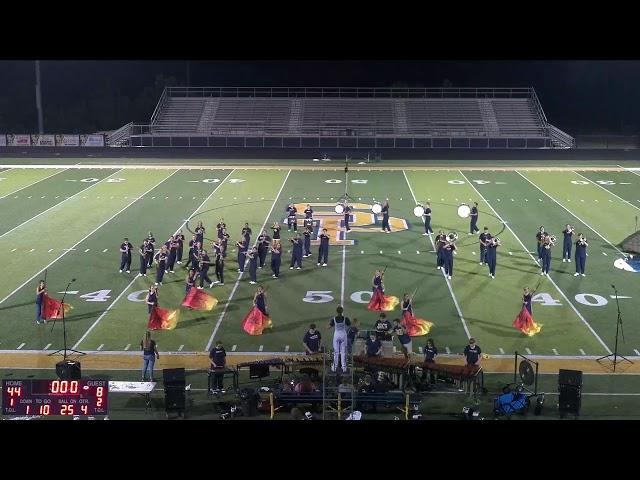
xmin=161 ymin=87 xmax=537 ymax=99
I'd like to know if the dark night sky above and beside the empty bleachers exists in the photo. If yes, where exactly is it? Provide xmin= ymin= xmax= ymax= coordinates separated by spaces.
xmin=0 ymin=60 xmax=640 ymax=134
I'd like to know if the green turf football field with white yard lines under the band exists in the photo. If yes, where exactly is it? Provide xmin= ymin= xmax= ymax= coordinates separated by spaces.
xmin=0 ymin=159 xmax=640 ymax=357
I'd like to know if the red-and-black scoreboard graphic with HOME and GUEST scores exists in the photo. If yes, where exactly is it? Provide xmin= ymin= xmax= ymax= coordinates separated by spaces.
xmin=2 ymin=379 xmax=109 ymax=416
